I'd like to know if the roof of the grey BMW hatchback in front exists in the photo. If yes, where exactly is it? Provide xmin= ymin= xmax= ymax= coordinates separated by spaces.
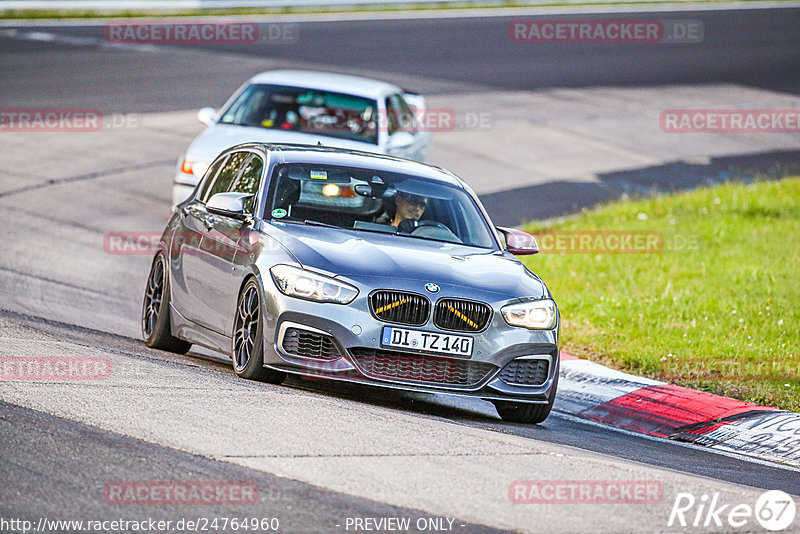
xmin=227 ymin=143 xmax=463 ymax=188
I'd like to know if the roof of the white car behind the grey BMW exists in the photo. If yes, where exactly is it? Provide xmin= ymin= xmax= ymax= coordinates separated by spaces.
xmin=250 ymin=70 xmax=402 ymax=100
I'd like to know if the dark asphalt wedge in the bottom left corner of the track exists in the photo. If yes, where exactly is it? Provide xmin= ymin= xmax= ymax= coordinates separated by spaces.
xmin=0 ymin=402 xmax=506 ymax=532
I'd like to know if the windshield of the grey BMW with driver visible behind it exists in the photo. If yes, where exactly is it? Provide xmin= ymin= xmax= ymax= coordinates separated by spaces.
xmin=267 ymin=164 xmax=496 ymax=248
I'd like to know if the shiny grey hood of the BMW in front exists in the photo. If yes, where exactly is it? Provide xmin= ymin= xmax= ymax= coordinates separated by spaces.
xmin=264 ymin=221 xmax=549 ymax=304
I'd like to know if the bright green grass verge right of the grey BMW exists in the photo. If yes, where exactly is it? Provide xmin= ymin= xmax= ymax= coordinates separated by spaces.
xmin=526 ymin=178 xmax=800 ymax=411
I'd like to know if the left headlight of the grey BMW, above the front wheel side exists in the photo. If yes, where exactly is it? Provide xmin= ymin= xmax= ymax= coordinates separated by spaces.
xmin=269 ymin=265 xmax=358 ymax=304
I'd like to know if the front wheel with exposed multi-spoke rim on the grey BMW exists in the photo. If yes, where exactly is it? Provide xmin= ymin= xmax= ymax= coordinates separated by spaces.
xmin=231 ymin=278 xmax=286 ymax=384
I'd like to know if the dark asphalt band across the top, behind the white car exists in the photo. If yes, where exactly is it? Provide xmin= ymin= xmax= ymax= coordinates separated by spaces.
xmin=0 ymin=9 xmax=800 ymax=113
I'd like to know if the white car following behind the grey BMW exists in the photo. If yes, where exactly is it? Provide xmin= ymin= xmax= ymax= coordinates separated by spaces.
xmin=172 ymin=70 xmax=428 ymax=206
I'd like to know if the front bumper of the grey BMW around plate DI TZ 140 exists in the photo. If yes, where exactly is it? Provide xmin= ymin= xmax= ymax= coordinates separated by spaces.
xmin=263 ymin=278 xmax=559 ymax=404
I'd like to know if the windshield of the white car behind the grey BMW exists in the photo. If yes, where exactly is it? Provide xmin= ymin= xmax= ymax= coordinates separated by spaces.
xmin=219 ymin=84 xmax=378 ymax=144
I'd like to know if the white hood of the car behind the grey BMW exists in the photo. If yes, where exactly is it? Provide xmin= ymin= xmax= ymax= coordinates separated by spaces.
xmin=186 ymin=124 xmax=378 ymax=163
